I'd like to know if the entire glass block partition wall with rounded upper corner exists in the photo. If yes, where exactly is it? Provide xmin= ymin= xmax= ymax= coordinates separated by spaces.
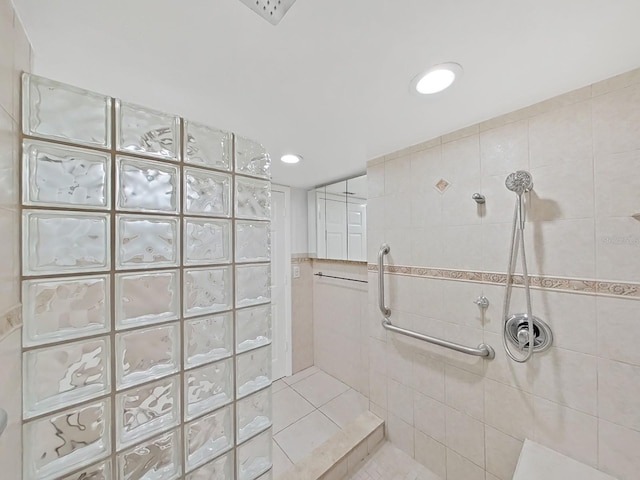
xmin=22 ymin=75 xmax=272 ymax=480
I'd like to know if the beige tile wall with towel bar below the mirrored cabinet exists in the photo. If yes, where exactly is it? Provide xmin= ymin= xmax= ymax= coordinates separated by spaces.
xmin=313 ymin=259 xmax=369 ymax=396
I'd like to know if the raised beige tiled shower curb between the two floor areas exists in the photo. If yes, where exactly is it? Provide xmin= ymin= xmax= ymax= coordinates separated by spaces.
xmin=275 ymin=412 xmax=384 ymax=480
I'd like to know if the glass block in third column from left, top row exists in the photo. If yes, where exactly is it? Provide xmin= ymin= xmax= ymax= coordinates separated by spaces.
xmin=184 ymin=120 xmax=231 ymax=171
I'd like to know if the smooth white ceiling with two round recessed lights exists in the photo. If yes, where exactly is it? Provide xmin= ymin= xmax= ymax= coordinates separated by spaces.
xmin=14 ymin=0 xmax=640 ymax=187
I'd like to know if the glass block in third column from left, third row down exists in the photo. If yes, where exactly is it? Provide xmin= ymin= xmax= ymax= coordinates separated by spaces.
xmin=184 ymin=218 xmax=231 ymax=265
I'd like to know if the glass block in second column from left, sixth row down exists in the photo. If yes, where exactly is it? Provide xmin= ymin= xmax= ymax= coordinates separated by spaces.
xmin=116 ymin=376 xmax=180 ymax=449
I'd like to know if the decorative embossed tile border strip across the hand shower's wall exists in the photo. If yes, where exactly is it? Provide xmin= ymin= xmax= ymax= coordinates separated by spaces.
xmin=367 ymin=263 xmax=640 ymax=300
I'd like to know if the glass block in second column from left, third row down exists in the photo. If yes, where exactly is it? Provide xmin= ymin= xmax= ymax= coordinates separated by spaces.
xmin=116 ymin=215 xmax=180 ymax=269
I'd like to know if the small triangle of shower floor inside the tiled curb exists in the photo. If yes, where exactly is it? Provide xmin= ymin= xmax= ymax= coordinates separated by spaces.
xmin=346 ymin=442 xmax=442 ymax=480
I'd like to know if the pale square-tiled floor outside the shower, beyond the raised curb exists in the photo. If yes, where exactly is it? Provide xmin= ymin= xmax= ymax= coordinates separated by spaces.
xmin=273 ymin=367 xmax=370 ymax=480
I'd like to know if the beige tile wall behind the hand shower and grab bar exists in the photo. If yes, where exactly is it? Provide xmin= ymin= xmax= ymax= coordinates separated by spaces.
xmin=368 ymin=69 xmax=640 ymax=480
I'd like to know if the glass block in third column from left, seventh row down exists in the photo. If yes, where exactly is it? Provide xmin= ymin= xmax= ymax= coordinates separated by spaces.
xmin=184 ymin=406 xmax=233 ymax=469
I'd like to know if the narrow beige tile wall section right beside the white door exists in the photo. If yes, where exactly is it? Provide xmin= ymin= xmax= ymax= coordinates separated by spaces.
xmin=291 ymin=258 xmax=313 ymax=373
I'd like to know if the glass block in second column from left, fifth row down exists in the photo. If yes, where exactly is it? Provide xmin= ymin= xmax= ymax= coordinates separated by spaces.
xmin=116 ymin=324 xmax=180 ymax=389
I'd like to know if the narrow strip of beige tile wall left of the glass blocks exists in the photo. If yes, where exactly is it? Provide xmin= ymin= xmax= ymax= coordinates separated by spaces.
xmin=0 ymin=0 xmax=32 ymax=478
